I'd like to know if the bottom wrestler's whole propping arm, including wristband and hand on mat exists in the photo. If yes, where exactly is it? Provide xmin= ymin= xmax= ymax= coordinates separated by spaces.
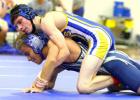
xmin=23 ymin=41 xmax=59 ymax=93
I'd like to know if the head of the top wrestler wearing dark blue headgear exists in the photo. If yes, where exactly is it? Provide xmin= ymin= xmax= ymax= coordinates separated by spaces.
xmin=10 ymin=4 xmax=37 ymax=33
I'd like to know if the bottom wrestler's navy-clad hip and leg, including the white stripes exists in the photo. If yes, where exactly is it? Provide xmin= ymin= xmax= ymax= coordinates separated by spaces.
xmin=102 ymin=50 xmax=140 ymax=92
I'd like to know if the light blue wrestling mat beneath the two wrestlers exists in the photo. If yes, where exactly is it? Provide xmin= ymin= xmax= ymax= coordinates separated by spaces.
xmin=0 ymin=55 xmax=140 ymax=100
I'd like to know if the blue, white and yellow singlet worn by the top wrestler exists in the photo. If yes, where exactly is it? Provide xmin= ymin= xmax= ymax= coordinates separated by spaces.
xmin=62 ymin=13 xmax=115 ymax=59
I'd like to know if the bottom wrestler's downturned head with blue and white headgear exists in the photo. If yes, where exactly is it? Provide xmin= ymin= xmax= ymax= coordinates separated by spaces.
xmin=15 ymin=34 xmax=48 ymax=64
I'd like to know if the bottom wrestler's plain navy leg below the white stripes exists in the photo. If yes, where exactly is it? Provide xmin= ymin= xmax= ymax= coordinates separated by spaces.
xmin=104 ymin=60 xmax=140 ymax=93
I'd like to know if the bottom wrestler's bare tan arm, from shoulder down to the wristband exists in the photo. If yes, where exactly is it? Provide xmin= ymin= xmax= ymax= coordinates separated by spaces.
xmin=40 ymin=41 xmax=59 ymax=81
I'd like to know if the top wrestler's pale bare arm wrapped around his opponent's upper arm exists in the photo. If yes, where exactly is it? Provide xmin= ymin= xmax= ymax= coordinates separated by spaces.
xmin=41 ymin=13 xmax=70 ymax=66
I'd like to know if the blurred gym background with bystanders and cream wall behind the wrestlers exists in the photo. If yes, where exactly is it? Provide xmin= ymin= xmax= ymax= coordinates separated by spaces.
xmin=0 ymin=0 xmax=140 ymax=59
